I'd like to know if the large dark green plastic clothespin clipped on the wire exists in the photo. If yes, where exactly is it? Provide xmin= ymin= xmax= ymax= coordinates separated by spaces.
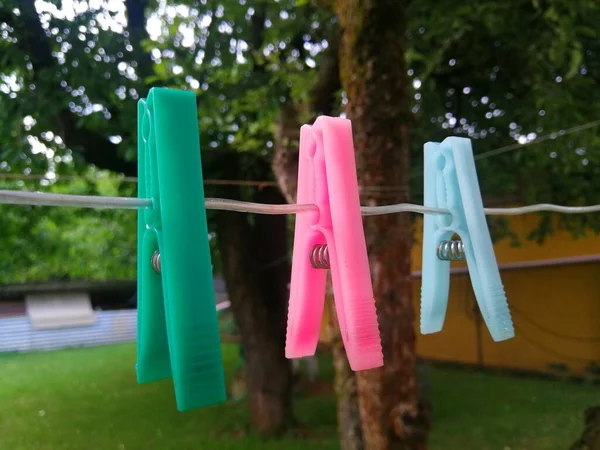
xmin=136 ymin=88 xmax=226 ymax=411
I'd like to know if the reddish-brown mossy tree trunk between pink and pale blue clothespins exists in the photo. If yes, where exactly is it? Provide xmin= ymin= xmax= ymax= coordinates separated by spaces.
xmin=336 ymin=0 xmax=429 ymax=450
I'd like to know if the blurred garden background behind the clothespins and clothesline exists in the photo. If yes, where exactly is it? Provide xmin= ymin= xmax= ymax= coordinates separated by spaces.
xmin=0 ymin=0 xmax=600 ymax=450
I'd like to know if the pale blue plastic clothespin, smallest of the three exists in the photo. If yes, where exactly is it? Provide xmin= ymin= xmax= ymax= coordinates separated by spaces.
xmin=421 ymin=137 xmax=515 ymax=341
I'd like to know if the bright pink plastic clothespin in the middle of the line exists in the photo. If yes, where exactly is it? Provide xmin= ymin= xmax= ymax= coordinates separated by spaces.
xmin=285 ymin=116 xmax=383 ymax=371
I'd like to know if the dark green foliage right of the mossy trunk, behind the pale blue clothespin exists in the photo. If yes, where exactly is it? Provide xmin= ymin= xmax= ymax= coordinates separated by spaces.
xmin=406 ymin=0 xmax=600 ymax=239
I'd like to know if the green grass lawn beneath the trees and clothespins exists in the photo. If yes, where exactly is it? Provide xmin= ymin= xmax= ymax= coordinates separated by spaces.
xmin=0 ymin=345 xmax=600 ymax=450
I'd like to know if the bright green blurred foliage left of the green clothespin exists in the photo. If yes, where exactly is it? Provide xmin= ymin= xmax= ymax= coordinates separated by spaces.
xmin=0 ymin=172 xmax=137 ymax=284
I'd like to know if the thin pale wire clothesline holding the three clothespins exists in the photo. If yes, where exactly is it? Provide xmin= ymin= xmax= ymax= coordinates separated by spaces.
xmin=0 ymin=190 xmax=600 ymax=216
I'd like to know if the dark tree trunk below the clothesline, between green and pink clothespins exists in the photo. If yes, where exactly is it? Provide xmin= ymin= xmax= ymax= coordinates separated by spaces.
xmin=216 ymin=154 xmax=293 ymax=434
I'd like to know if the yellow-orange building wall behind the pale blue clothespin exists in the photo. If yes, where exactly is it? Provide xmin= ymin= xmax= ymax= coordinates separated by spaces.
xmin=324 ymin=214 xmax=600 ymax=375
